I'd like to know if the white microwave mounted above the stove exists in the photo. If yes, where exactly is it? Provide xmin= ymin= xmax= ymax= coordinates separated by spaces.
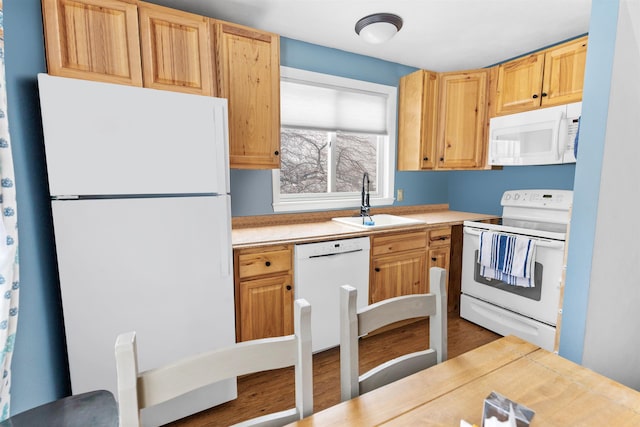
xmin=489 ymin=102 xmax=582 ymax=166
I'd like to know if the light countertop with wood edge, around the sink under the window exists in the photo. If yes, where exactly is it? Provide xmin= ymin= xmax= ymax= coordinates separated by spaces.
xmin=231 ymin=205 xmax=496 ymax=249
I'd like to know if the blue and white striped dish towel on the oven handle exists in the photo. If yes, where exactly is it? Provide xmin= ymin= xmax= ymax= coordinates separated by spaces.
xmin=478 ymin=231 xmax=536 ymax=288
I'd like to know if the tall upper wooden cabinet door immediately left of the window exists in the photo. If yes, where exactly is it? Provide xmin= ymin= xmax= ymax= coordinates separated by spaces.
xmin=213 ymin=21 xmax=280 ymax=169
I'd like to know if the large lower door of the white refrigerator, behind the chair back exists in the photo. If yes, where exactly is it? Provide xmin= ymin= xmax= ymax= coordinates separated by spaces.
xmin=52 ymin=196 xmax=236 ymax=425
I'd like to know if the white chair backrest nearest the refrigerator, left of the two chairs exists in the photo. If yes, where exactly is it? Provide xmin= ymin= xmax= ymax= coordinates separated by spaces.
xmin=115 ymin=299 xmax=313 ymax=427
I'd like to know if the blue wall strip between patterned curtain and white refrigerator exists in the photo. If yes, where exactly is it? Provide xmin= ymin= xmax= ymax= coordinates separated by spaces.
xmin=3 ymin=0 xmax=70 ymax=414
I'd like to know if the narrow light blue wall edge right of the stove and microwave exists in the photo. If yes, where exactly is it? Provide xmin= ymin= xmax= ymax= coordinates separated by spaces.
xmin=560 ymin=0 xmax=619 ymax=363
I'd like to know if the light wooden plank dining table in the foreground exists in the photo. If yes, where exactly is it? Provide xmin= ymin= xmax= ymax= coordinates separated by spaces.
xmin=292 ymin=336 xmax=640 ymax=427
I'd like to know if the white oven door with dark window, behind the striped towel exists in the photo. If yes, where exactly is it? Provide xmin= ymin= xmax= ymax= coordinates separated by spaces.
xmin=462 ymin=227 xmax=565 ymax=326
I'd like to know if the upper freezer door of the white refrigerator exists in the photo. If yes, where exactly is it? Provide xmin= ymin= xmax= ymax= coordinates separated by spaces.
xmin=38 ymin=74 xmax=229 ymax=196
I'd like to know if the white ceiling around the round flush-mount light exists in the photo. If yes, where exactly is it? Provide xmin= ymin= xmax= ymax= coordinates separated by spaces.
xmin=148 ymin=0 xmax=591 ymax=72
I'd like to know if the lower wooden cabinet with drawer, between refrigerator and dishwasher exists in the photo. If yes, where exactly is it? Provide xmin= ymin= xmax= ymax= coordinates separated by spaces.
xmin=234 ymin=245 xmax=294 ymax=341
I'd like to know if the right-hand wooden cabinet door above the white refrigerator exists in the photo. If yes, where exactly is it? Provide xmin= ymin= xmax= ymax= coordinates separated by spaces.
xmin=139 ymin=3 xmax=215 ymax=96
